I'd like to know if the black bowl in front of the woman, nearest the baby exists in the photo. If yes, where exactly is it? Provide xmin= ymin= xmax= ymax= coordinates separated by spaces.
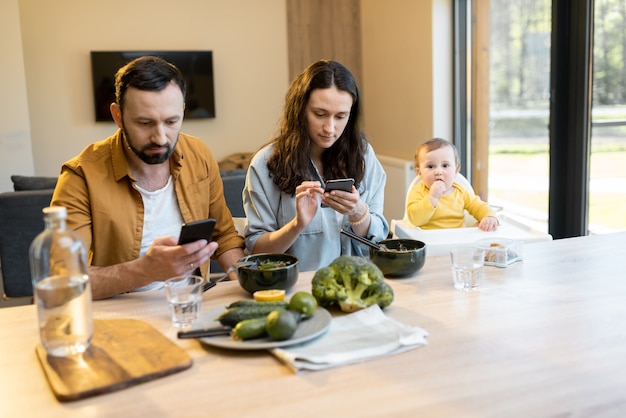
xmin=370 ymin=239 xmax=426 ymax=277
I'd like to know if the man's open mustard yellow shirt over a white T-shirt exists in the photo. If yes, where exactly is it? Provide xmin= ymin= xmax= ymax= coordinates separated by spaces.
xmin=51 ymin=130 xmax=243 ymax=274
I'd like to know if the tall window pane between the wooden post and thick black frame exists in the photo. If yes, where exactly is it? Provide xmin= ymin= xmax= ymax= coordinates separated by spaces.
xmin=488 ymin=0 xmax=551 ymax=232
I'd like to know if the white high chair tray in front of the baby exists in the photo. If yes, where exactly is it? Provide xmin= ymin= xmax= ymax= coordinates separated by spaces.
xmin=394 ymin=215 xmax=552 ymax=256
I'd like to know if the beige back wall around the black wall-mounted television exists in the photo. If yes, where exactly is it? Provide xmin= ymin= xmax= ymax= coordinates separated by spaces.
xmin=12 ymin=0 xmax=289 ymax=185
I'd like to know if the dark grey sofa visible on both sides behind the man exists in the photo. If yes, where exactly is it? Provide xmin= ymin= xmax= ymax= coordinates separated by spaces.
xmin=0 ymin=169 xmax=246 ymax=301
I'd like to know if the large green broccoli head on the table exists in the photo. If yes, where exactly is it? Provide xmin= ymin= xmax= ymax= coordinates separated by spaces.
xmin=311 ymin=255 xmax=393 ymax=312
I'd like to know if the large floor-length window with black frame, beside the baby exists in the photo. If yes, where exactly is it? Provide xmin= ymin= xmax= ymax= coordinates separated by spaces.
xmin=455 ymin=0 xmax=626 ymax=238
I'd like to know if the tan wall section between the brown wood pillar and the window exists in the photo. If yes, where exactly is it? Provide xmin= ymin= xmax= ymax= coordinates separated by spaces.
xmin=361 ymin=0 xmax=448 ymax=160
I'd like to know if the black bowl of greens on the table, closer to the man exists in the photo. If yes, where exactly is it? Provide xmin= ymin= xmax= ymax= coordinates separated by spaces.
xmin=238 ymin=253 xmax=298 ymax=293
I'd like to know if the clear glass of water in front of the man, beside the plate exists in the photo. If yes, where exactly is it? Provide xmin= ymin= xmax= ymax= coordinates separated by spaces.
xmin=165 ymin=275 xmax=203 ymax=328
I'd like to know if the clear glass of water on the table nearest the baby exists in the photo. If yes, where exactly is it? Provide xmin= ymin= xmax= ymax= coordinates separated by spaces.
xmin=450 ymin=245 xmax=485 ymax=291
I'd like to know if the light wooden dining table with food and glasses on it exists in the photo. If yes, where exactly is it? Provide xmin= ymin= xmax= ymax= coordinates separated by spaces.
xmin=0 ymin=233 xmax=626 ymax=418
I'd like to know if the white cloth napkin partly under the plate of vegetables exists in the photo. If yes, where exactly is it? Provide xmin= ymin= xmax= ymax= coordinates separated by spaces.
xmin=270 ymin=305 xmax=428 ymax=372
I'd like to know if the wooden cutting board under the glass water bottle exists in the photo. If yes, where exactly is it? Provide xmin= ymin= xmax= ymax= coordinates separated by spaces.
xmin=36 ymin=319 xmax=192 ymax=401
